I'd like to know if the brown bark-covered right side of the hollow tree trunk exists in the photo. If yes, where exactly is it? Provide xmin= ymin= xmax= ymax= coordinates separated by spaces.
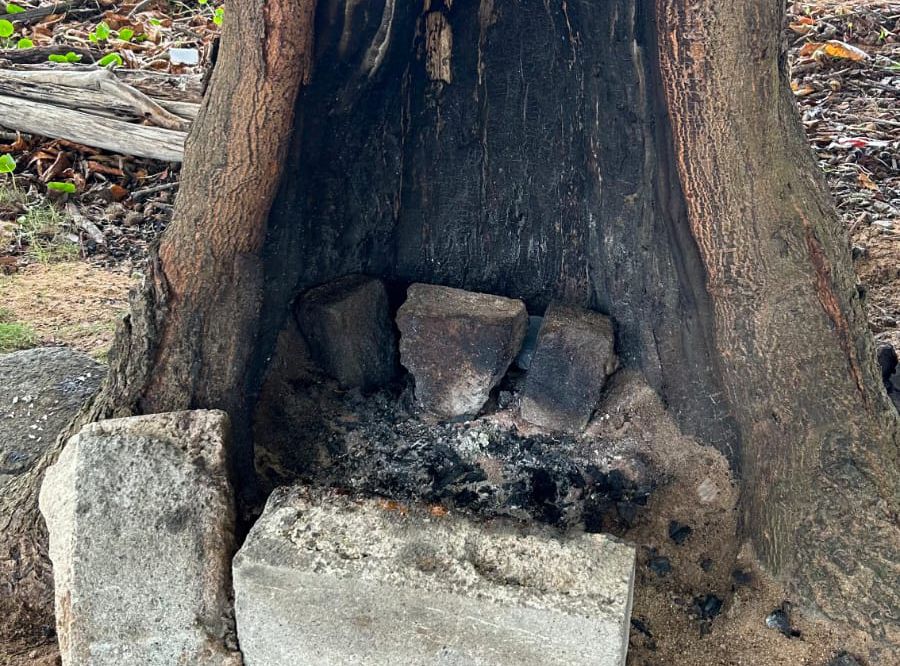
xmin=657 ymin=0 xmax=900 ymax=647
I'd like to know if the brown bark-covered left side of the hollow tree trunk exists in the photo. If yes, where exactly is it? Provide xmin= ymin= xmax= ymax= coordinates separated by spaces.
xmin=0 ymin=0 xmax=314 ymax=658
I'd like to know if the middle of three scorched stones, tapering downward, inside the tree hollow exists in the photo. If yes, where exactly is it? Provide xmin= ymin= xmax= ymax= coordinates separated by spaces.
xmin=397 ymin=284 xmax=528 ymax=419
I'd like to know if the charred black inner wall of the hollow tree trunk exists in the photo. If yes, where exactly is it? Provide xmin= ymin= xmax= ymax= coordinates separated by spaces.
xmin=257 ymin=0 xmax=736 ymax=460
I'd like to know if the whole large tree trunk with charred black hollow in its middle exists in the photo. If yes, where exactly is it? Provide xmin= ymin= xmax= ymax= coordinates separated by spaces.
xmin=3 ymin=0 xmax=900 ymax=656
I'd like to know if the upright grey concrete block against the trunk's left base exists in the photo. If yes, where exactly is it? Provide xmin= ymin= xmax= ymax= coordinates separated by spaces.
xmin=40 ymin=411 xmax=240 ymax=666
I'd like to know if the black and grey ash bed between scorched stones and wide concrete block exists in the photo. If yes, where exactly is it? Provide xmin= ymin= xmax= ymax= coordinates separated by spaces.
xmin=268 ymin=386 xmax=652 ymax=532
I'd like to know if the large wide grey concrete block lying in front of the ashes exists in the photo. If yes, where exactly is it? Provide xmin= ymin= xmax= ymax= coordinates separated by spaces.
xmin=234 ymin=487 xmax=635 ymax=666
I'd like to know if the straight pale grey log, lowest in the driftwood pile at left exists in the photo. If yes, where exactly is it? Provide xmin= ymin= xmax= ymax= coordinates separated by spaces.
xmin=0 ymin=95 xmax=187 ymax=162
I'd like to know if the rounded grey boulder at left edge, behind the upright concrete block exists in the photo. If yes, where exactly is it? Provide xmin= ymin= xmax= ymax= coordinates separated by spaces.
xmin=0 ymin=347 xmax=106 ymax=487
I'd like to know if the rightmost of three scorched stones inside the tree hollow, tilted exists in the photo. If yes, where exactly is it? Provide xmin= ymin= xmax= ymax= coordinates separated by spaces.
xmin=521 ymin=303 xmax=618 ymax=434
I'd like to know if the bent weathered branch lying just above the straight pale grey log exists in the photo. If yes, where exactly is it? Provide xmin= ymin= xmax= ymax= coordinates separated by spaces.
xmin=0 ymin=69 xmax=190 ymax=131
